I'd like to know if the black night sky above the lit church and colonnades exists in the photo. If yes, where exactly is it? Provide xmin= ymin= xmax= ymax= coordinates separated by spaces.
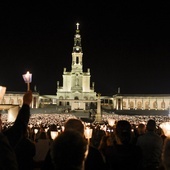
xmin=0 ymin=0 xmax=170 ymax=95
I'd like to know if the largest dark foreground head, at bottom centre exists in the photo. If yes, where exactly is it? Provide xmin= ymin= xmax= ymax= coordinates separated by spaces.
xmin=50 ymin=130 xmax=87 ymax=170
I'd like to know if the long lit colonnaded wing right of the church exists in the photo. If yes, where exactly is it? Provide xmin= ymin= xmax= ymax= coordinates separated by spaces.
xmin=101 ymin=93 xmax=170 ymax=115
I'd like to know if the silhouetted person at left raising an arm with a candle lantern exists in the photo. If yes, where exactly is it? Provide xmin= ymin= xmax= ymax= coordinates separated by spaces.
xmin=0 ymin=91 xmax=32 ymax=170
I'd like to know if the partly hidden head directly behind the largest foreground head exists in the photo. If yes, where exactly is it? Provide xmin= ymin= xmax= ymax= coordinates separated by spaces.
xmin=64 ymin=118 xmax=84 ymax=135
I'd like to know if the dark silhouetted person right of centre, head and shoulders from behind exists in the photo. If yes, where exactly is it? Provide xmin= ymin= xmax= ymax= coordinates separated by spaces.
xmin=104 ymin=120 xmax=142 ymax=170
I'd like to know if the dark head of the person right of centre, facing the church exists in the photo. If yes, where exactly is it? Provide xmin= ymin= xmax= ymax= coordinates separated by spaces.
xmin=115 ymin=120 xmax=131 ymax=144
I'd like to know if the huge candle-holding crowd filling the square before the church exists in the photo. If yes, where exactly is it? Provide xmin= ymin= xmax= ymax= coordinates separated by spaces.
xmin=0 ymin=91 xmax=170 ymax=170
